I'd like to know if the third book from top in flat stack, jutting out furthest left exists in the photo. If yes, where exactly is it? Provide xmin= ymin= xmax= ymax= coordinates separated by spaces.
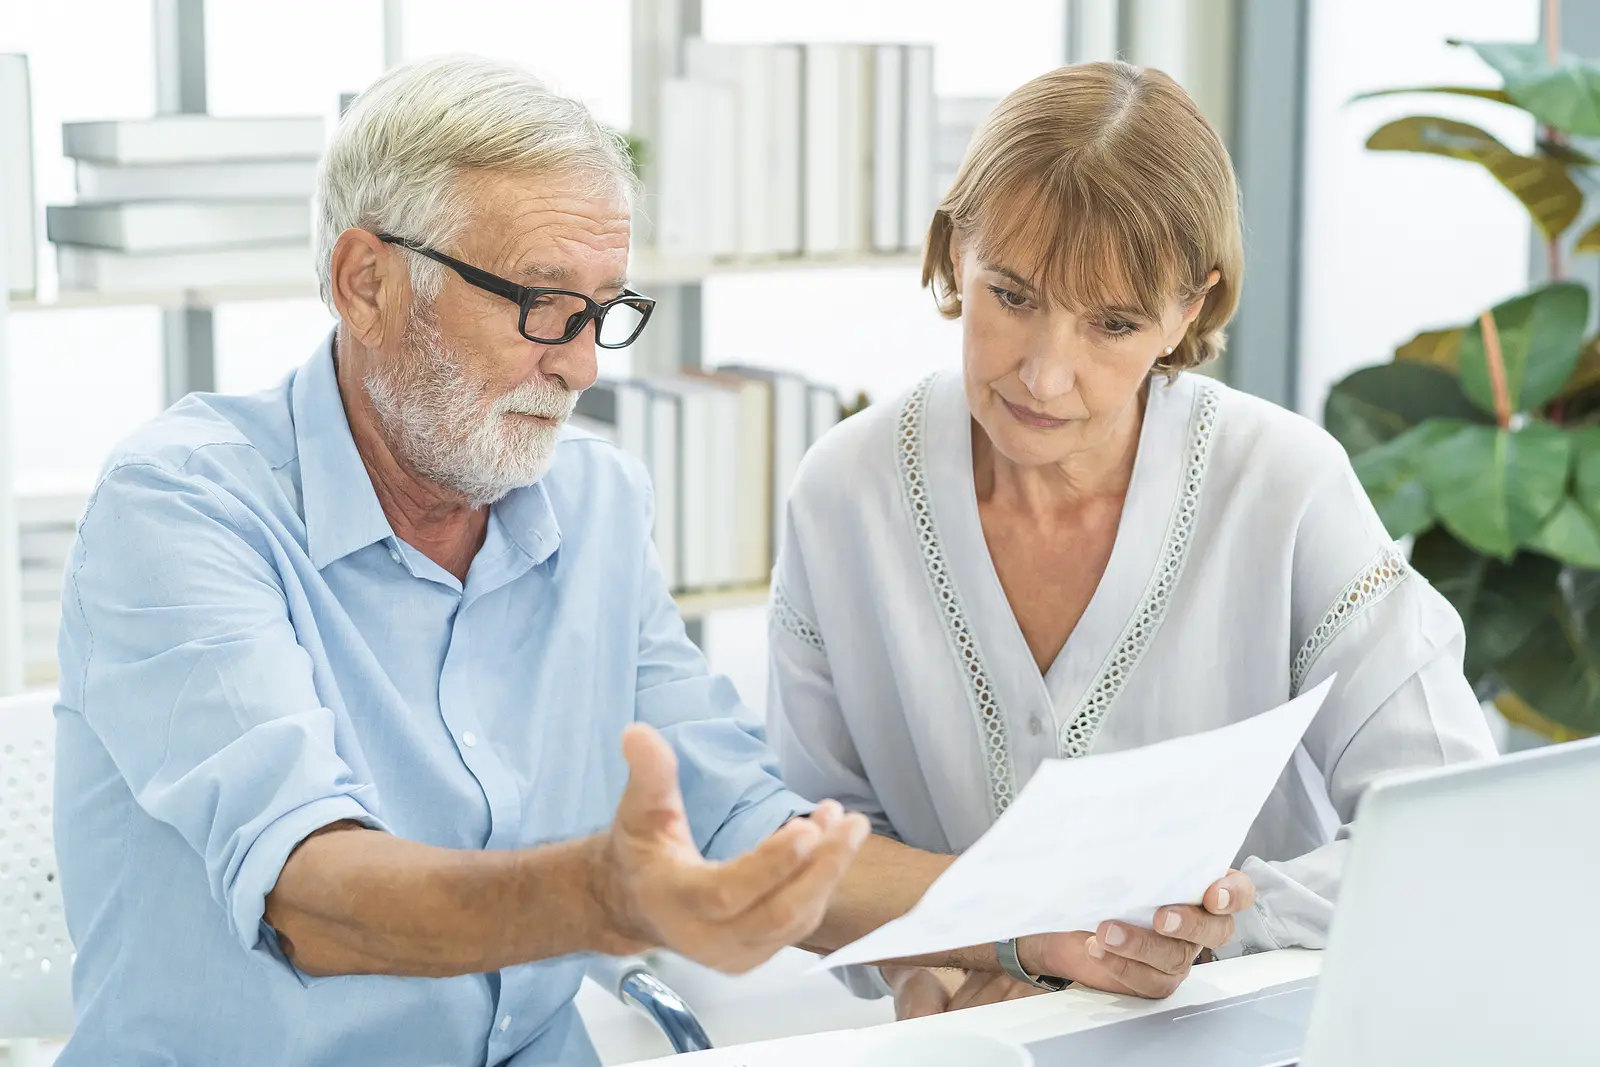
xmin=45 ymin=200 xmax=310 ymax=253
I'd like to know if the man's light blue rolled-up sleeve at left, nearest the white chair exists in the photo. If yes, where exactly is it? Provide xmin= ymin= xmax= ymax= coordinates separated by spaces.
xmin=61 ymin=462 xmax=384 ymax=950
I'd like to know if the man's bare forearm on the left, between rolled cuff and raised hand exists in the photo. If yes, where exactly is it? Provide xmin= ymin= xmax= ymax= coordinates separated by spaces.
xmin=266 ymin=825 xmax=640 ymax=977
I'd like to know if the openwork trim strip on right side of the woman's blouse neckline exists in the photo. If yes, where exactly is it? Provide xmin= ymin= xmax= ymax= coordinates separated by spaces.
xmin=1058 ymin=378 xmax=1219 ymax=758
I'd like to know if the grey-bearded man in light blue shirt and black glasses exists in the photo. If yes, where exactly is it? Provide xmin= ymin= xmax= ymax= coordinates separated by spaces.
xmin=58 ymin=58 xmax=1248 ymax=1067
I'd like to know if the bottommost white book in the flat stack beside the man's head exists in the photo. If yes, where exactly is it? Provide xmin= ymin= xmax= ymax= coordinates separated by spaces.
xmin=56 ymin=245 xmax=315 ymax=293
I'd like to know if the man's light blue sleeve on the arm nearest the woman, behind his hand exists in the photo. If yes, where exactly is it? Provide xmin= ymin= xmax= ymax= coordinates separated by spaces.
xmin=635 ymin=489 xmax=814 ymax=859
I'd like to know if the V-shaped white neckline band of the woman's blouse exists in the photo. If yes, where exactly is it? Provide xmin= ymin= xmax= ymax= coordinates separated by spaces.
xmin=920 ymin=374 xmax=1214 ymax=767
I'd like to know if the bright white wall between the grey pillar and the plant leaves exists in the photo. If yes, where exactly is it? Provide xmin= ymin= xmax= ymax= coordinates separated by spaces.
xmin=1292 ymin=0 xmax=1539 ymax=418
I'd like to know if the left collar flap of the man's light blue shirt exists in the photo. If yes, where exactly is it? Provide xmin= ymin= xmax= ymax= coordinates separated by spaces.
xmin=291 ymin=333 xmax=394 ymax=569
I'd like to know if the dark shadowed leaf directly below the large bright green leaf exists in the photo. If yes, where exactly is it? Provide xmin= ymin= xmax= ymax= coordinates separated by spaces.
xmin=1411 ymin=528 xmax=1560 ymax=686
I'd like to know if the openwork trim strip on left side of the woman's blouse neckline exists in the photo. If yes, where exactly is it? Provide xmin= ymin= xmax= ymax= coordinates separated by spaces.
xmin=898 ymin=376 xmax=1016 ymax=817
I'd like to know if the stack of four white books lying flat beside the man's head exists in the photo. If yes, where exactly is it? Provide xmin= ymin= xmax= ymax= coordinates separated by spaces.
xmin=45 ymin=115 xmax=323 ymax=291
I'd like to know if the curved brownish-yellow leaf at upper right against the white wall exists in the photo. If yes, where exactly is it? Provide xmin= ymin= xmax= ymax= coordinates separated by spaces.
xmin=1366 ymin=115 xmax=1584 ymax=240
